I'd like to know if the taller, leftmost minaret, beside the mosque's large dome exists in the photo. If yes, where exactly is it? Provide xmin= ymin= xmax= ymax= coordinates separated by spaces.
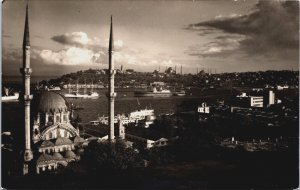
xmin=20 ymin=4 xmax=33 ymax=174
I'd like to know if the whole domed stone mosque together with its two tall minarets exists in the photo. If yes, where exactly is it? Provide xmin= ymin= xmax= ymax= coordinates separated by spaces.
xmin=20 ymin=5 xmax=117 ymax=175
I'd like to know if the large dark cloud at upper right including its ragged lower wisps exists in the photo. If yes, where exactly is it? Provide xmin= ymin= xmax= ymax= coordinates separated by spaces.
xmin=189 ymin=1 xmax=299 ymax=59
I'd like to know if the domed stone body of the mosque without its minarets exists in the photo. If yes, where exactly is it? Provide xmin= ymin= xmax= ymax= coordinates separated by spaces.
xmin=32 ymin=91 xmax=86 ymax=173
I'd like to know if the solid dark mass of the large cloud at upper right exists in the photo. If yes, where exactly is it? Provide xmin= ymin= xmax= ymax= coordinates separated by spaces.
xmin=194 ymin=1 xmax=299 ymax=50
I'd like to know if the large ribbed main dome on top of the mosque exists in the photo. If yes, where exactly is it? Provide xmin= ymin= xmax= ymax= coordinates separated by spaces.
xmin=37 ymin=91 xmax=68 ymax=113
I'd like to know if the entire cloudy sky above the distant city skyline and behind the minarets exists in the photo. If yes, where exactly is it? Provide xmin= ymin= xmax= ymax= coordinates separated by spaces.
xmin=2 ymin=0 xmax=299 ymax=76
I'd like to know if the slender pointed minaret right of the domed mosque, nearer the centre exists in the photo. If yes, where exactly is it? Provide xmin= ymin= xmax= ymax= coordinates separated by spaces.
xmin=108 ymin=16 xmax=117 ymax=142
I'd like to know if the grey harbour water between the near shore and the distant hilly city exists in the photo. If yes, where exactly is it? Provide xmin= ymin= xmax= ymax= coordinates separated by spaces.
xmin=2 ymin=89 xmax=232 ymax=127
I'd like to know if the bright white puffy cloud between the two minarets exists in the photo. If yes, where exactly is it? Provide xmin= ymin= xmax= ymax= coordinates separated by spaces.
xmin=36 ymin=31 xmax=123 ymax=65
